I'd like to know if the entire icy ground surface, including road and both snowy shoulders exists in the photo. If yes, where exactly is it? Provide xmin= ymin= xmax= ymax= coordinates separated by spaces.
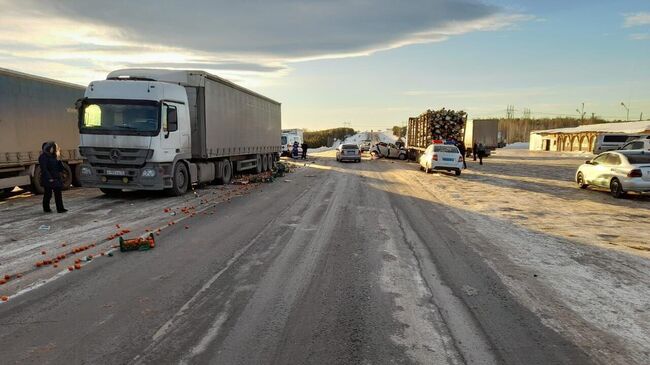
xmin=0 ymin=151 xmax=650 ymax=364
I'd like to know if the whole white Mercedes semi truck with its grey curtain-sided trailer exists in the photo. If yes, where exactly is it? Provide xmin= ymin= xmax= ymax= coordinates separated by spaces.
xmin=77 ymin=69 xmax=281 ymax=195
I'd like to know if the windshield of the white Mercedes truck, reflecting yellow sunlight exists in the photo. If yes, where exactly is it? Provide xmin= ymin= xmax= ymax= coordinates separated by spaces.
xmin=79 ymin=100 xmax=160 ymax=136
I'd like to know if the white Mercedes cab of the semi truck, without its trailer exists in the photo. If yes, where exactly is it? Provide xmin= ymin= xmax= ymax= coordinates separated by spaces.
xmin=78 ymin=78 xmax=192 ymax=194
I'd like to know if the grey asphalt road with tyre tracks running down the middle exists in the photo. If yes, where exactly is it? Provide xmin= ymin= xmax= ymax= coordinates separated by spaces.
xmin=0 ymin=153 xmax=592 ymax=364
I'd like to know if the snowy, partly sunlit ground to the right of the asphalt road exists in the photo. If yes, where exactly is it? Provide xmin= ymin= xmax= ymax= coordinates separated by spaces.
xmin=400 ymin=150 xmax=650 ymax=364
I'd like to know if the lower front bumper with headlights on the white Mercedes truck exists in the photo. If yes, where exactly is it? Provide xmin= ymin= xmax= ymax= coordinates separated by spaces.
xmin=79 ymin=163 xmax=172 ymax=190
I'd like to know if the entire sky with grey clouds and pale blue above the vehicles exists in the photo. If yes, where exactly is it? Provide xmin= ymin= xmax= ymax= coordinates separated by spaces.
xmin=0 ymin=0 xmax=650 ymax=130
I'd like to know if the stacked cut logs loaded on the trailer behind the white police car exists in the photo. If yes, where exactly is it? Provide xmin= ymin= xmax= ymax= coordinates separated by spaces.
xmin=407 ymin=108 xmax=467 ymax=148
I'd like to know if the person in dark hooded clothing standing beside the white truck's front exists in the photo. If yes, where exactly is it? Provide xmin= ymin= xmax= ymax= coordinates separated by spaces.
xmin=38 ymin=141 xmax=68 ymax=213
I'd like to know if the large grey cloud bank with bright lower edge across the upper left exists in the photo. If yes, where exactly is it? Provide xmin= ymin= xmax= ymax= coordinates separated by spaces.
xmin=0 ymin=0 xmax=530 ymax=86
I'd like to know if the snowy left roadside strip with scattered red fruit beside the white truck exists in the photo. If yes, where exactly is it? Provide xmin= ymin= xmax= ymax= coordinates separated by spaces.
xmin=0 ymin=184 xmax=270 ymax=295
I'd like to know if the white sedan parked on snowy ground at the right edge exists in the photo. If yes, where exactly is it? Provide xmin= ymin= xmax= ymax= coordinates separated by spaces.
xmin=576 ymin=151 xmax=650 ymax=198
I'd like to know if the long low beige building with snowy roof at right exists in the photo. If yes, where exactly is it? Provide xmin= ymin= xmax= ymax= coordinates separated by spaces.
xmin=529 ymin=121 xmax=650 ymax=152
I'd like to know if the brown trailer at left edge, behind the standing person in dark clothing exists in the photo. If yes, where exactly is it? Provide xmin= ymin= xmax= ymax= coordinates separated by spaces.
xmin=0 ymin=68 xmax=85 ymax=195
